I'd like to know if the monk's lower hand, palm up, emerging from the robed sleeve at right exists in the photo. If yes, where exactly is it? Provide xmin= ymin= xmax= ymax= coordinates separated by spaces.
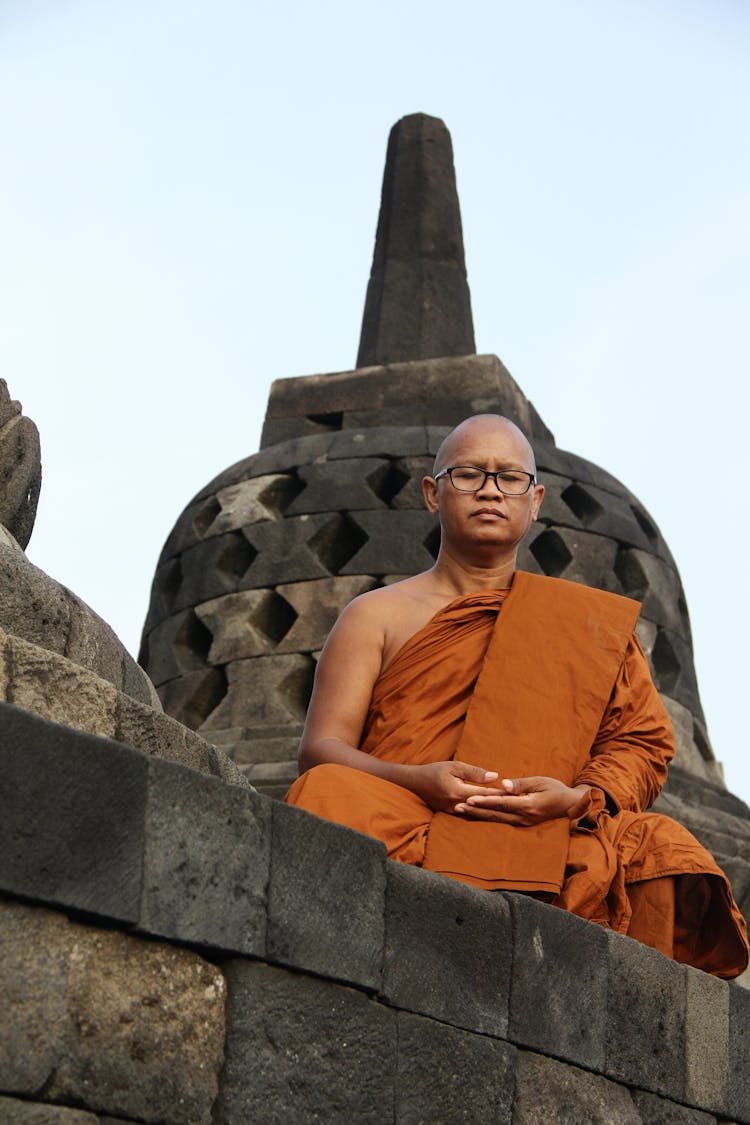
xmin=454 ymin=777 xmax=589 ymax=828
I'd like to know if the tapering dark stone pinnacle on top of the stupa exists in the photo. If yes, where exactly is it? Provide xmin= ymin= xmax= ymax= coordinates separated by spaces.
xmin=356 ymin=114 xmax=476 ymax=367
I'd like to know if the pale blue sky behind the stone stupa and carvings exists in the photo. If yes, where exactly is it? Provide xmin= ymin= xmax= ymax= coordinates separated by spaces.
xmin=0 ymin=0 xmax=750 ymax=801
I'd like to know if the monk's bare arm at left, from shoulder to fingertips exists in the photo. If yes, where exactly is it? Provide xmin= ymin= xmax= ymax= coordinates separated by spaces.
xmin=299 ymin=592 xmax=500 ymax=811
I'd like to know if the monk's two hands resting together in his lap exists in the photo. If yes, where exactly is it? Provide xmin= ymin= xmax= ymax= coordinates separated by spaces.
xmin=409 ymin=762 xmax=588 ymax=827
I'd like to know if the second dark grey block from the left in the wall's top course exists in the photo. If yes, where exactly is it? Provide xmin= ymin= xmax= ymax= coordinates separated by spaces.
xmin=139 ymin=758 xmax=271 ymax=956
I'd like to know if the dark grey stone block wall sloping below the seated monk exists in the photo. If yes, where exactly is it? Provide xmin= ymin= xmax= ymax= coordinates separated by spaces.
xmin=0 ymin=703 xmax=750 ymax=1125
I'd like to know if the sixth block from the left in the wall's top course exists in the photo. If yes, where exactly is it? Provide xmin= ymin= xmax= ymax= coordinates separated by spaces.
xmin=605 ymin=932 xmax=687 ymax=1101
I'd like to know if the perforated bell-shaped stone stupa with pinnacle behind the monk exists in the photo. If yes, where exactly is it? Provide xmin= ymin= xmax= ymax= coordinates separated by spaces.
xmin=141 ymin=114 xmax=750 ymax=927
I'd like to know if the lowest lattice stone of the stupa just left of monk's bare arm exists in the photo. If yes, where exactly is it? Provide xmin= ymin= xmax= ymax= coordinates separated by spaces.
xmin=200 ymin=654 xmax=314 ymax=738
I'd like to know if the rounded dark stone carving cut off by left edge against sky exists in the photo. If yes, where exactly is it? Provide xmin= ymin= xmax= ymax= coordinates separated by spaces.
xmin=0 ymin=379 xmax=42 ymax=547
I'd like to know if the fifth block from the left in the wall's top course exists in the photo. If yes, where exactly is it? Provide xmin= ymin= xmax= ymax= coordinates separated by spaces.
xmin=505 ymin=893 xmax=608 ymax=1070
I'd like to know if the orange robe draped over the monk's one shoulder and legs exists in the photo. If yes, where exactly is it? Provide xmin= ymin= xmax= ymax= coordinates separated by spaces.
xmin=287 ymin=572 xmax=748 ymax=977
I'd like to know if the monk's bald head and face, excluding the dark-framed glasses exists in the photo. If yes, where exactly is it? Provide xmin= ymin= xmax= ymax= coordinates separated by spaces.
xmin=423 ymin=417 xmax=544 ymax=548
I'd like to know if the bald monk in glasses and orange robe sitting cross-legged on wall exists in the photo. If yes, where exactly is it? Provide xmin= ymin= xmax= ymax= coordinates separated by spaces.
xmin=286 ymin=414 xmax=748 ymax=978
